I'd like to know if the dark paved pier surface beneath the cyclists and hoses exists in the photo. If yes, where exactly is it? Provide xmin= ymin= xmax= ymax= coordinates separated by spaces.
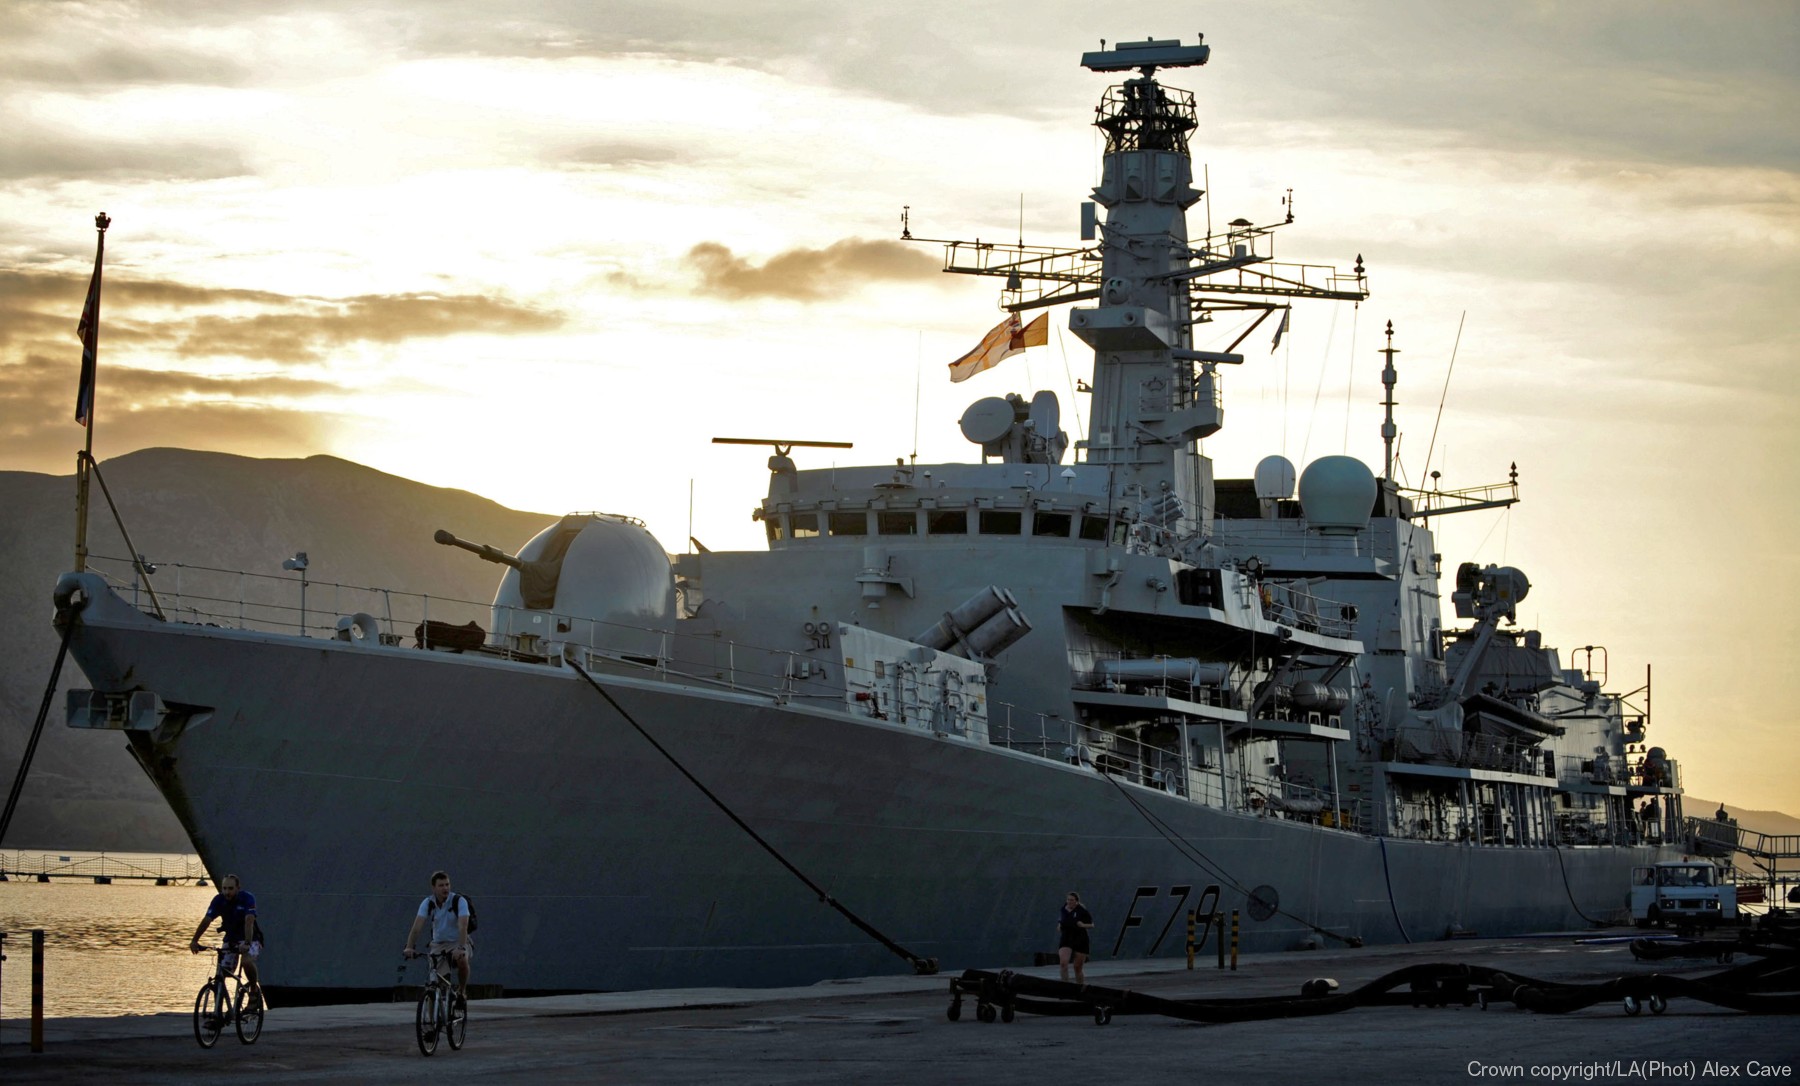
xmin=0 ymin=933 xmax=1800 ymax=1086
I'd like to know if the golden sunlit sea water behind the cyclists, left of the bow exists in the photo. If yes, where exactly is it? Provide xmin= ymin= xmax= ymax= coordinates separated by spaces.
xmin=0 ymin=850 xmax=214 ymax=1037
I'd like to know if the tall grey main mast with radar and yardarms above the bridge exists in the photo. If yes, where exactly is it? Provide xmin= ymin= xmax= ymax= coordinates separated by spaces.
xmin=904 ymin=40 xmax=1368 ymax=540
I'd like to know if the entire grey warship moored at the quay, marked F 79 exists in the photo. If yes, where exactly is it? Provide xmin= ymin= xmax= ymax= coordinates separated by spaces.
xmin=54 ymin=40 xmax=1683 ymax=992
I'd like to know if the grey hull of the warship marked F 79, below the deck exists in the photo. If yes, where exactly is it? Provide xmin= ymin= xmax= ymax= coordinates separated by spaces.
xmin=59 ymin=593 xmax=1656 ymax=991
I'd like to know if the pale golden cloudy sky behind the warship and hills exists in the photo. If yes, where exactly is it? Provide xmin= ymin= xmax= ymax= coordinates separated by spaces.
xmin=0 ymin=0 xmax=1800 ymax=810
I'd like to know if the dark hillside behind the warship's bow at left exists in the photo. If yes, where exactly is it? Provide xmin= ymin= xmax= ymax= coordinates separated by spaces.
xmin=0 ymin=448 xmax=553 ymax=850
